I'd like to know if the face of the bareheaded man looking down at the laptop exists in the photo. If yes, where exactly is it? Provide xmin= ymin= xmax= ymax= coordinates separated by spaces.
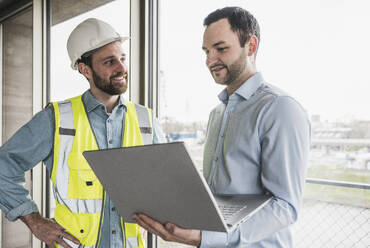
xmin=202 ymin=18 xmax=251 ymax=90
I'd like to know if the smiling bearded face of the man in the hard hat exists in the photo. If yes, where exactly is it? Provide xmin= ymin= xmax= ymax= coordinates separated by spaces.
xmin=88 ymin=42 xmax=128 ymax=95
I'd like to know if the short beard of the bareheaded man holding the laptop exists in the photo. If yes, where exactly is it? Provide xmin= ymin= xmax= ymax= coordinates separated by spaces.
xmin=211 ymin=49 xmax=247 ymax=85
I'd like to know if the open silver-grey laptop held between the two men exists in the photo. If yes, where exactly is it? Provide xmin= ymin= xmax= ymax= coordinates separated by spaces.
xmin=83 ymin=142 xmax=271 ymax=232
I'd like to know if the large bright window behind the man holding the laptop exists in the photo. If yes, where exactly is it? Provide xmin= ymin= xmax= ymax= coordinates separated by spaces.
xmin=159 ymin=0 xmax=370 ymax=247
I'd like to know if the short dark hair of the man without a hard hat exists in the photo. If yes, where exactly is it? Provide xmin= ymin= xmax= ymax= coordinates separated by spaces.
xmin=203 ymin=7 xmax=260 ymax=47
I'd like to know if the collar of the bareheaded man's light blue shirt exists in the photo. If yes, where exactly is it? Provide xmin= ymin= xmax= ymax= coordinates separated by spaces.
xmin=218 ymin=72 xmax=264 ymax=104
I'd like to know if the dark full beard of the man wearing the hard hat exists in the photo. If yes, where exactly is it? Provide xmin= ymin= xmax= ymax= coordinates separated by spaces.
xmin=92 ymin=69 xmax=127 ymax=96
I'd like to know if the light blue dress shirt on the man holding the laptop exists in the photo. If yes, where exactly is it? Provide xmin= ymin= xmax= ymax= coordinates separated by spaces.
xmin=200 ymin=73 xmax=311 ymax=248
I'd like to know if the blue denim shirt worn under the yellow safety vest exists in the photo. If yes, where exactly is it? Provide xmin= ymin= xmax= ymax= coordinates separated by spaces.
xmin=0 ymin=91 xmax=165 ymax=248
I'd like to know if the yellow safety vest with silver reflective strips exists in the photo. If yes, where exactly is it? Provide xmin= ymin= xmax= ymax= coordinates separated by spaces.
xmin=51 ymin=96 xmax=153 ymax=248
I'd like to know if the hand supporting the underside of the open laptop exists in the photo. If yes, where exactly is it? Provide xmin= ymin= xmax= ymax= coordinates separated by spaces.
xmin=132 ymin=214 xmax=201 ymax=246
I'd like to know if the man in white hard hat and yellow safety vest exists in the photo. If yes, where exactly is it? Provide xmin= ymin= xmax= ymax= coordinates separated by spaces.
xmin=0 ymin=18 xmax=164 ymax=248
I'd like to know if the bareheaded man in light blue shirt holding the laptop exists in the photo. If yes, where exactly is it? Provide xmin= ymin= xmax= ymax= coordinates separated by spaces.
xmin=135 ymin=7 xmax=310 ymax=248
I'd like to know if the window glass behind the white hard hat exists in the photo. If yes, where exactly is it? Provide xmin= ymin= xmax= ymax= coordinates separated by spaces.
xmin=50 ymin=0 xmax=130 ymax=216
